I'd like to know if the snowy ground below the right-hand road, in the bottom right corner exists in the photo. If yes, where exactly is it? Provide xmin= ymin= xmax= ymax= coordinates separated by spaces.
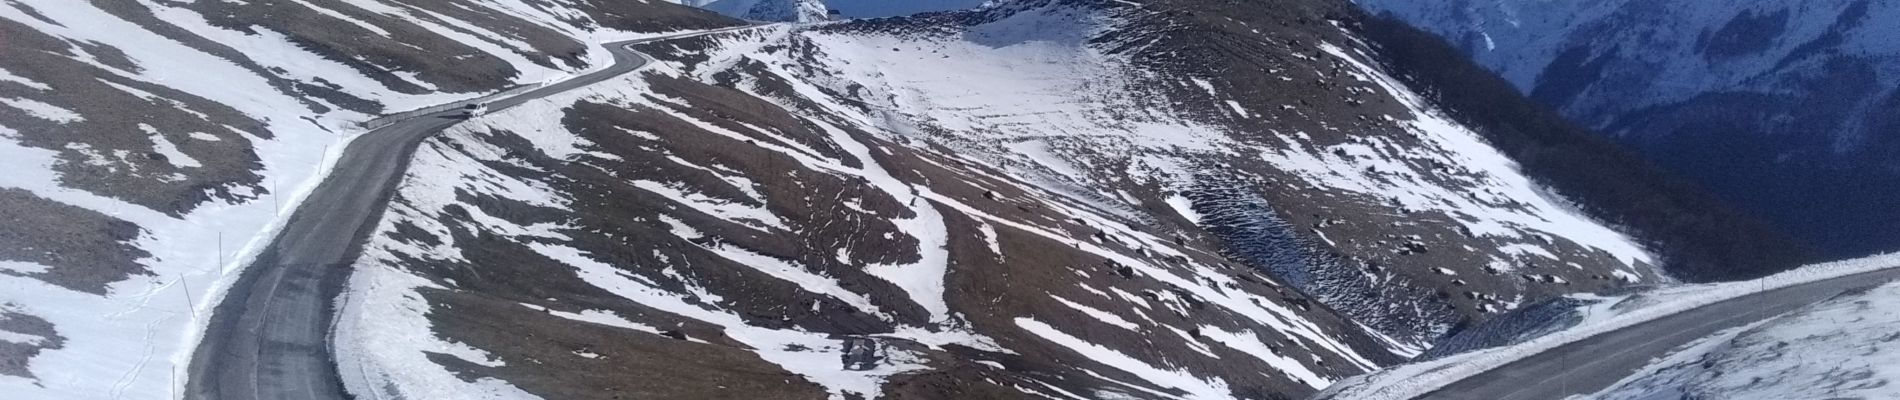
xmin=1590 ymin=282 xmax=1900 ymax=400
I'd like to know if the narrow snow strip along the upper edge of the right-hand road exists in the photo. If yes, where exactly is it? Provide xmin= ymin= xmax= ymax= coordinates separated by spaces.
xmin=1321 ymin=254 xmax=1900 ymax=400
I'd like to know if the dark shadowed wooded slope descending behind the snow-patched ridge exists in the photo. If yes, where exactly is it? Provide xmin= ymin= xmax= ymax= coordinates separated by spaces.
xmin=1360 ymin=19 xmax=1811 ymax=281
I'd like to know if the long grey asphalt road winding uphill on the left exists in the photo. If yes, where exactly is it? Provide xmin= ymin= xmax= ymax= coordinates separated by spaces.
xmin=186 ymin=27 xmax=745 ymax=400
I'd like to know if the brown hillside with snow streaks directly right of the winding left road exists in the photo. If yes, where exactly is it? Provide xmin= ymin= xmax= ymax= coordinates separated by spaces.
xmin=338 ymin=16 xmax=1391 ymax=398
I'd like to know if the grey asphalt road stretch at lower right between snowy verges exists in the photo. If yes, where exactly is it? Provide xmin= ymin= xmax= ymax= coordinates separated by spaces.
xmin=1419 ymin=269 xmax=1900 ymax=400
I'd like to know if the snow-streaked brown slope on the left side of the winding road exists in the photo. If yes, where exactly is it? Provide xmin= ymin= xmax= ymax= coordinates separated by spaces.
xmin=0 ymin=0 xmax=737 ymax=398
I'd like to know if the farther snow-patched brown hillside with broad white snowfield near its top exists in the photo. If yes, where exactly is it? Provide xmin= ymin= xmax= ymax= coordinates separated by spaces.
xmin=768 ymin=0 xmax=1679 ymax=341
